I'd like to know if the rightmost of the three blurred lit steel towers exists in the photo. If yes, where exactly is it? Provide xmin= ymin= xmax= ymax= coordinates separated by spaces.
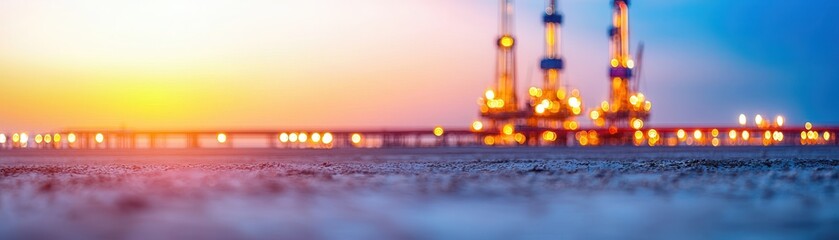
xmin=590 ymin=0 xmax=652 ymax=132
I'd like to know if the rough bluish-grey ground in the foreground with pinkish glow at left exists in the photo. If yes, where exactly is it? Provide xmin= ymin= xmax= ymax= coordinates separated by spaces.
xmin=0 ymin=147 xmax=839 ymax=239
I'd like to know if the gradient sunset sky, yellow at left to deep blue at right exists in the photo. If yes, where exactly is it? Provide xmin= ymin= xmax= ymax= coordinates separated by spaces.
xmin=0 ymin=0 xmax=839 ymax=131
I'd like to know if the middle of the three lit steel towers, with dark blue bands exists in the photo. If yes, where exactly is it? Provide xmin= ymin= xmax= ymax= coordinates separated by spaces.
xmin=528 ymin=0 xmax=582 ymax=129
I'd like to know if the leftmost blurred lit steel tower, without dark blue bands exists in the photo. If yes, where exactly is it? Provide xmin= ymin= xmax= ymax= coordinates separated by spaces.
xmin=479 ymin=0 xmax=522 ymax=138
